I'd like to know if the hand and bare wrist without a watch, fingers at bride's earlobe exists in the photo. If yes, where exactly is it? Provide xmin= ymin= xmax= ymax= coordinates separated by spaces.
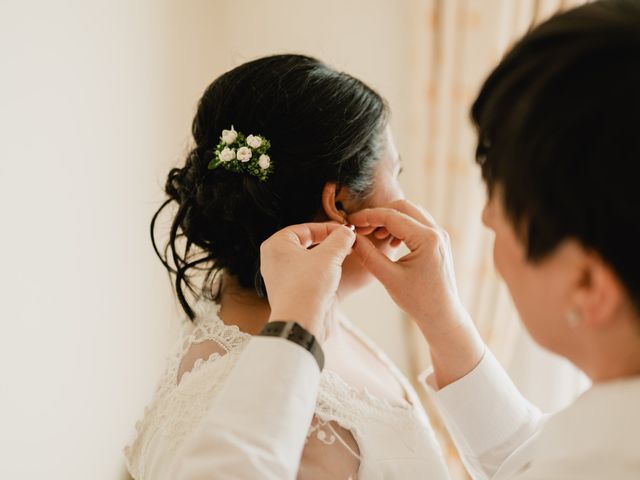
xmin=348 ymin=200 xmax=485 ymax=388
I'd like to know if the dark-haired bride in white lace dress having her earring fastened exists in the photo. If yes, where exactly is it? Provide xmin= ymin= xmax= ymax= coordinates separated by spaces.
xmin=125 ymin=55 xmax=448 ymax=480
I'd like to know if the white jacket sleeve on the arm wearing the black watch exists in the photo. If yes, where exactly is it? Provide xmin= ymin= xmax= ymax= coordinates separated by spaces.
xmin=166 ymin=337 xmax=320 ymax=480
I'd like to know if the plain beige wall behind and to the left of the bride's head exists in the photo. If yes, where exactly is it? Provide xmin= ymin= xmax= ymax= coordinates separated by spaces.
xmin=0 ymin=0 xmax=418 ymax=479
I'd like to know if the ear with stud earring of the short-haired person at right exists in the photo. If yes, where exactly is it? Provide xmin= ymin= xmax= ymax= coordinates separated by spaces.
xmin=575 ymin=248 xmax=625 ymax=329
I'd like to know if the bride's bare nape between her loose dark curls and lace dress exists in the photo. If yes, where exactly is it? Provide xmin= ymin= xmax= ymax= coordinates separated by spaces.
xmin=219 ymin=274 xmax=341 ymax=335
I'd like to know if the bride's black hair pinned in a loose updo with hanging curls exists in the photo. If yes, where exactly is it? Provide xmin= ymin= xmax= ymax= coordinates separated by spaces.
xmin=151 ymin=55 xmax=388 ymax=319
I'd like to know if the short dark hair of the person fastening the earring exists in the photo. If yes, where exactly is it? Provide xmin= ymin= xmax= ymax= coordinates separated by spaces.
xmin=471 ymin=0 xmax=640 ymax=309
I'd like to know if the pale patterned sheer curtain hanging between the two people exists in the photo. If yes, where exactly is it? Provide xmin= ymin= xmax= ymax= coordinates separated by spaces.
xmin=406 ymin=0 xmax=586 ymax=477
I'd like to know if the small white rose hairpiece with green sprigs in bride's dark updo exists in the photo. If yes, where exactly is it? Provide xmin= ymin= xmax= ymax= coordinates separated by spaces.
xmin=208 ymin=125 xmax=273 ymax=181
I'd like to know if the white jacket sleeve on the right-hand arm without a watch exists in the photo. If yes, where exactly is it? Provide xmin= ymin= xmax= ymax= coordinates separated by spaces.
xmin=423 ymin=349 xmax=543 ymax=479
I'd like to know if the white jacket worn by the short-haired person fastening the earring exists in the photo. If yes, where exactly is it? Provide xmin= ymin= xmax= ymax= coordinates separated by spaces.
xmin=167 ymin=337 xmax=640 ymax=480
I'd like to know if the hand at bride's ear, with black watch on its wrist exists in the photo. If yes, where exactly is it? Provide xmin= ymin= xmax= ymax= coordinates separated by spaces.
xmin=260 ymin=223 xmax=356 ymax=342
